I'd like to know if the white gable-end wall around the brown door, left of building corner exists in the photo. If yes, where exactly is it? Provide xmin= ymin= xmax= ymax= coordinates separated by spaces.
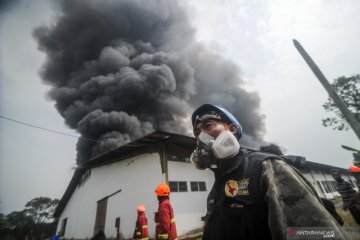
xmin=57 ymin=153 xmax=162 ymax=239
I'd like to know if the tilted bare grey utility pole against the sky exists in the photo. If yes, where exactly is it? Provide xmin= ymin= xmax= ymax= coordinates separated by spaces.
xmin=293 ymin=39 xmax=360 ymax=140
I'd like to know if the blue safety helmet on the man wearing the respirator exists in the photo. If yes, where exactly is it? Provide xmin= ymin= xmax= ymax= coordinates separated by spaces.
xmin=191 ymin=104 xmax=242 ymax=140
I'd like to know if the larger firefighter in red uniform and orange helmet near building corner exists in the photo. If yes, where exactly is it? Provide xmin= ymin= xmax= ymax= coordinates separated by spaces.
xmin=155 ymin=183 xmax=177 ymax=240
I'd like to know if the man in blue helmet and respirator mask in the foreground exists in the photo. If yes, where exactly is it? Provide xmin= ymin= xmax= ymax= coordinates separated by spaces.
xmin=191 ymin=104 xmax=348 ymax=240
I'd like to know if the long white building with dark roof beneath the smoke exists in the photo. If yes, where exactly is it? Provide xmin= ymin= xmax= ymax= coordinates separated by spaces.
xmin=55 ymin=132 xmax=355 ymax=239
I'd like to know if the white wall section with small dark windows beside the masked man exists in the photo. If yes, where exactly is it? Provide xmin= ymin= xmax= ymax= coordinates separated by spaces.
xmin=168 ymin=161 xmax=215 ymax=235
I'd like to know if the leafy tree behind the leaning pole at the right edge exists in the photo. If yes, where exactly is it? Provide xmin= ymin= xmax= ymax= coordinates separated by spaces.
xmin=322 ymin=75 xmax=360 ymax=131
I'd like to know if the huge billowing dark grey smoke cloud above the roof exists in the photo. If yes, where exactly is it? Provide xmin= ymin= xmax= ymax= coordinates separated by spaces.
xmin=34 ymin=0 xmax=264 ymax=164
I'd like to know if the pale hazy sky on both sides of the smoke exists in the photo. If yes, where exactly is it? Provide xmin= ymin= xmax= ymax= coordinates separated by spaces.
xmin=0 ymin=0 xmax=360 ymax=214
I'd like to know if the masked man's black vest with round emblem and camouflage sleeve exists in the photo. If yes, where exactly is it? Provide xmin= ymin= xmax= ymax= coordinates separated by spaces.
xmin=203 ymin=150 xmax=347 ymax=240
